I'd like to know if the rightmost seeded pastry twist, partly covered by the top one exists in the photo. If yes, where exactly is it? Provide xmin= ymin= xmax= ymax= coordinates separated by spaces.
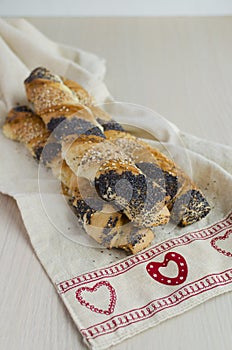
xmin=61 ymin=80 xmax=211 ymax=226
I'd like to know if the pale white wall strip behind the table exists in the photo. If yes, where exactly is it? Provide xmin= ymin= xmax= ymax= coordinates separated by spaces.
xmin=0 ymin=0 xmax=232 ymax=16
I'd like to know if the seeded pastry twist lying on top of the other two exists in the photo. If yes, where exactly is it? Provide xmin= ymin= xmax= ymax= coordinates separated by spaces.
xmin=25 ymin=67 xmax=170 ymax=227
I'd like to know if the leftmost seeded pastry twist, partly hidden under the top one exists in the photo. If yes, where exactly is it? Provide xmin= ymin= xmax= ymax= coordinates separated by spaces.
xmin=3 ymin=106 xmax=154 ymax=254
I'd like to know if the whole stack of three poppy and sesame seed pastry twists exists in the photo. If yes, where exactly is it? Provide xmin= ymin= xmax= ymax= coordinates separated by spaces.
xmin=3 ymin=67 xmax=210 ymax=254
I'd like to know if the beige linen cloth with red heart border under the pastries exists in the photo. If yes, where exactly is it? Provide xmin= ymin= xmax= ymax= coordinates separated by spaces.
xmin=0 ymin=19 xmax=232 ymax=349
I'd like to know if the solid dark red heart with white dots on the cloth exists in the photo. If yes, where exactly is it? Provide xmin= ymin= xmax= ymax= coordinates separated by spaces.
xmin=146 ymin=252 xmax=188 ymax=286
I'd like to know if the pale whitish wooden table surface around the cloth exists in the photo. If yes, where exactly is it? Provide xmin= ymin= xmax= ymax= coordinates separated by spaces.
xmin=0 ymin=17 xmax=232 ymax=350
